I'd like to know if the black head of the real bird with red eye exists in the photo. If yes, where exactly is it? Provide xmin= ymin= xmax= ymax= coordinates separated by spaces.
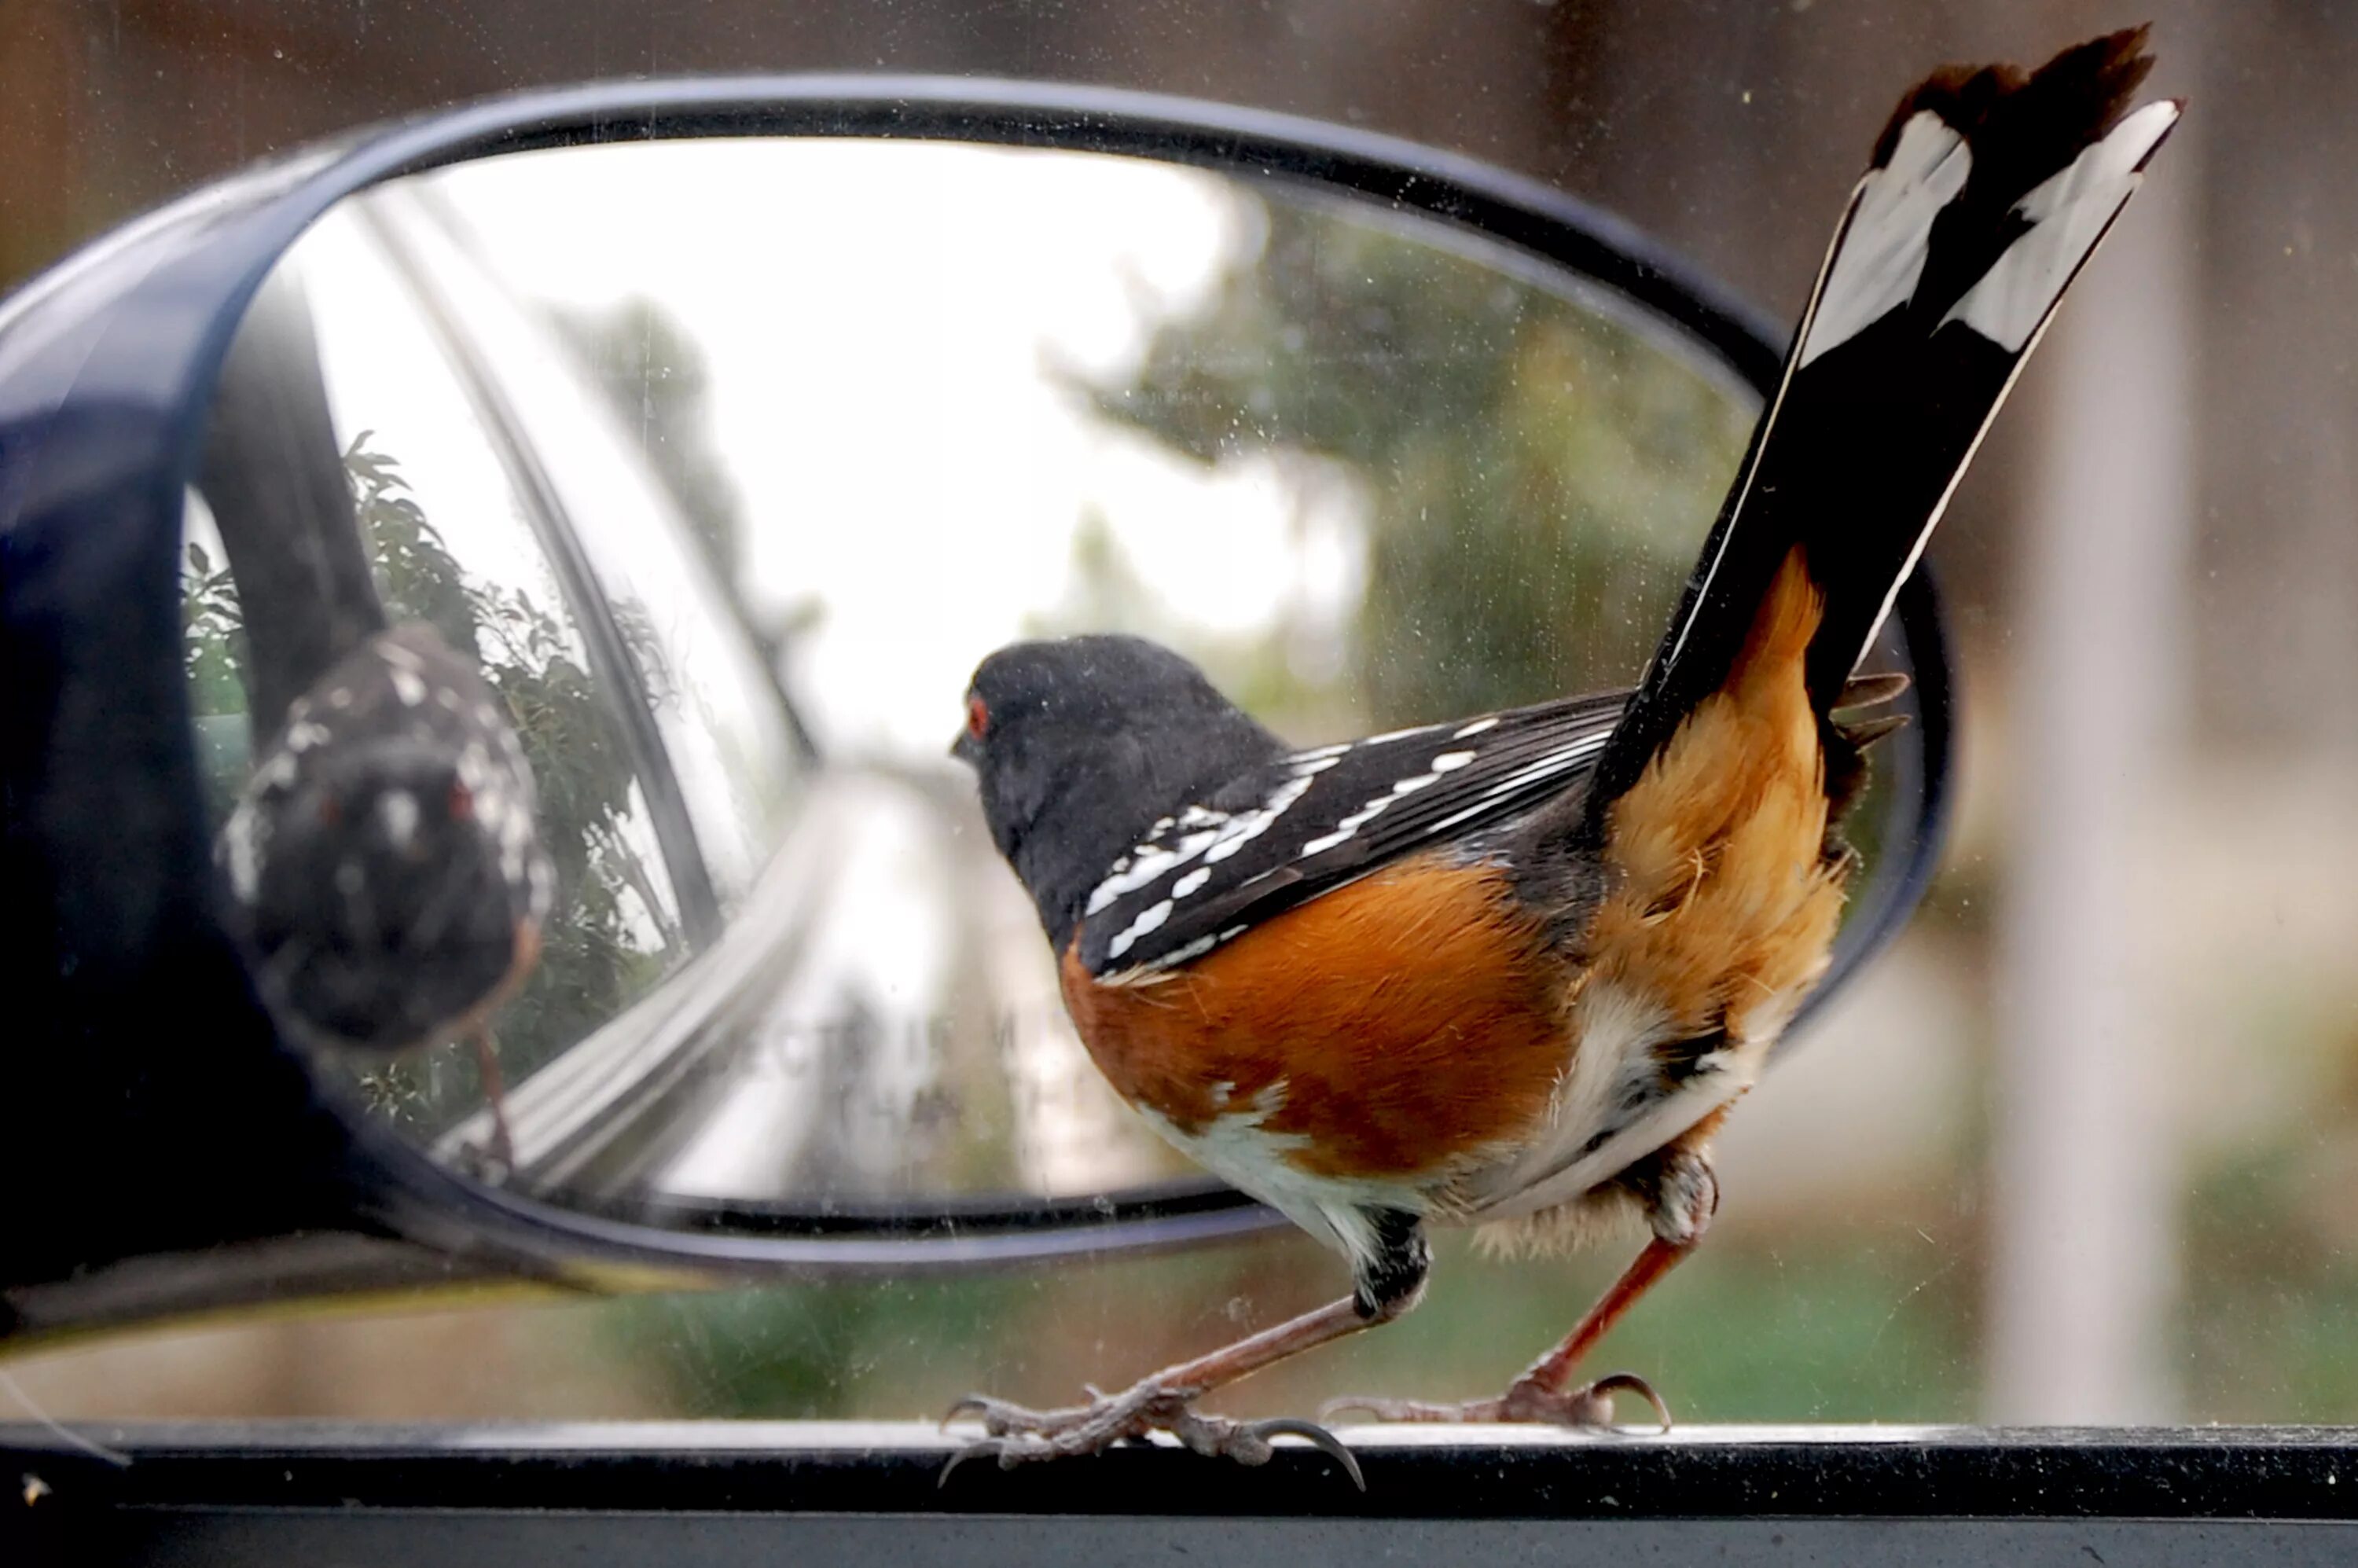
xmin=950 ymin=637 xmax=1285 ymax=946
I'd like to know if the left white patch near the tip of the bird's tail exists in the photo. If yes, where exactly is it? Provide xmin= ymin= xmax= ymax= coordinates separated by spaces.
xmin=1802 ymin=108 xmax=1974 ymax=365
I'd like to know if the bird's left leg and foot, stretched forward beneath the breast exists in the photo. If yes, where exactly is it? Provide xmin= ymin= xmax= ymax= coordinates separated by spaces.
xmin=941 ymin=1212 xmax=1431 ymax=1490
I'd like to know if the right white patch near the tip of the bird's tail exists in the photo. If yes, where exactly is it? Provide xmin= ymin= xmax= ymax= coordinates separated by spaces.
xmin=1941 ymin=101 xmax=2179 ymax=354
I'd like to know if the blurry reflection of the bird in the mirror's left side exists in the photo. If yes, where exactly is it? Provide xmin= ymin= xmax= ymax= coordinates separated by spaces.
xmin=217 ymin=622 xmax=556 ymax=1170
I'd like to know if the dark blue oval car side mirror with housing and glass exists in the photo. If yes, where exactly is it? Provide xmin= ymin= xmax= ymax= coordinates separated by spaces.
xmin=0 ymin=78 xmax=1950 ymax=1335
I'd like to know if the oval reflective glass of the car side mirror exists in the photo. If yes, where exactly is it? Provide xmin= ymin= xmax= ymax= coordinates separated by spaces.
xmin=184 ymin=139 xmax=1891 ymax=1233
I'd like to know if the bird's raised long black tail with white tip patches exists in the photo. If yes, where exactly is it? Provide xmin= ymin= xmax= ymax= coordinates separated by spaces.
xmin=1587 ymin=28 xmax=2179 ymax=830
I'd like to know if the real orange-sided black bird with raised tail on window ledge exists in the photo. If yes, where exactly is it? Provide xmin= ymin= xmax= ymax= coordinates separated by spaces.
xmin=953 ymin=28 xmax=2179 ymax=1474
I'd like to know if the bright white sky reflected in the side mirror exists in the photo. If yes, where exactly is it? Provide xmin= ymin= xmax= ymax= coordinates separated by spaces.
xmin=389 ymin=141 xmax=1358 ymax=757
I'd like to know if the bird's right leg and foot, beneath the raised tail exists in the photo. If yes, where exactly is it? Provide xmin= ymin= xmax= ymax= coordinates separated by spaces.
xmin=1318 ymin=1139 xmax=1719 ymax=1431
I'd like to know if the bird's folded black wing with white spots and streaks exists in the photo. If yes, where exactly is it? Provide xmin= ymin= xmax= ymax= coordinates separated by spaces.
xmin=1078 ymin=691 xmax=1629 ymax=976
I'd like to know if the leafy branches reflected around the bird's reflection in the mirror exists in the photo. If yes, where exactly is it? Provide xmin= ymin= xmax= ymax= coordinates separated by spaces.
xmin=182 ymin=431 xmax=677 ymax=1127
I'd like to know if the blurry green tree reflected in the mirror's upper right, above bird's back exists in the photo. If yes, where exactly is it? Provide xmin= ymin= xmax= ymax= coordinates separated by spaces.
xmin=1092 ymin=200 xmax=1750 ymax=724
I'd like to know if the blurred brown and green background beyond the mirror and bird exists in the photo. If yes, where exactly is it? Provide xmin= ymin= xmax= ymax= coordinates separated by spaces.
xmin=0 ymin=0 xmax=2358 ymax=1422
